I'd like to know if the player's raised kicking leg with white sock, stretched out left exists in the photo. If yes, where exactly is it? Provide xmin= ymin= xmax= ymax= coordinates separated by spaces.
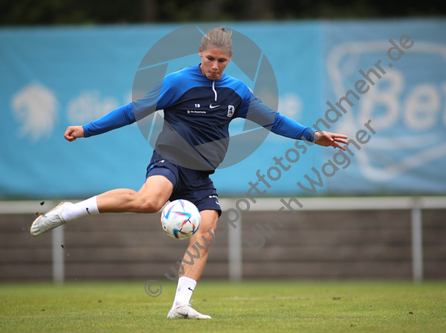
xmin=30 ymin=175 xmax=173 ymax=236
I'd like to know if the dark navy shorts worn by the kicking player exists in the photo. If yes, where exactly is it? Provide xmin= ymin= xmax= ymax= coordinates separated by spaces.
xmin=146 ymin=151 xmax=221 ymax=216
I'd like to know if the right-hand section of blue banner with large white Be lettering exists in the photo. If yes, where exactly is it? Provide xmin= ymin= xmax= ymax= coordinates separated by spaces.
xmin=323 ymin=20 xmax=446 ymax=194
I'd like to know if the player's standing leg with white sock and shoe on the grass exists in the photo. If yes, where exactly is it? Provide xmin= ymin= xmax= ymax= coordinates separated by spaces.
xmin=167 ymin=210 xmax=218 ymax=319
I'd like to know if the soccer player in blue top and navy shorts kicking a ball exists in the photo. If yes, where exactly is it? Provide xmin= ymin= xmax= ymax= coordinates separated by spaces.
xmin=30 ymin=27 xmax=347 ymax=319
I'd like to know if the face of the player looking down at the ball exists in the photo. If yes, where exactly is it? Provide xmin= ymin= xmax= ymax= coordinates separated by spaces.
xmin=198 ymin=46 xmax=232 ymax=80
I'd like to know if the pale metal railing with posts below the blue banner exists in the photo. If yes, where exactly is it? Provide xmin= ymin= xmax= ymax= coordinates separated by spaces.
xmin=0 ymin=196 xmax=446 ymax=283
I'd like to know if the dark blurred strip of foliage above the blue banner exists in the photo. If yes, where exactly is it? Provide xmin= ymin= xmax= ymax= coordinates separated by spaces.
xmin=1 ymin=0 xmax=446 ymax=25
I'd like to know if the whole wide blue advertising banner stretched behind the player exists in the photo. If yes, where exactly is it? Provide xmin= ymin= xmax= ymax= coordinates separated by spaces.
xmin=0 ymin=20 xmax=446 ymax=199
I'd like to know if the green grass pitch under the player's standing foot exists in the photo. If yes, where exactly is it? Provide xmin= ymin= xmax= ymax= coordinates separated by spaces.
xmin=0 ymin=280 xmax=446 ymax=333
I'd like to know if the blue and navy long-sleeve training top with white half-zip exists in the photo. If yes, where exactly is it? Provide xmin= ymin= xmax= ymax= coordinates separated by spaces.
xmin=84 ymin=65 xmax=314 ymax=170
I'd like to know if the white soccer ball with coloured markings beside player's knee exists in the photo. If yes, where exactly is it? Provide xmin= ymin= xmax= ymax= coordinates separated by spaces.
xmin=161 ymin=199 xmax=201 ymax=239
